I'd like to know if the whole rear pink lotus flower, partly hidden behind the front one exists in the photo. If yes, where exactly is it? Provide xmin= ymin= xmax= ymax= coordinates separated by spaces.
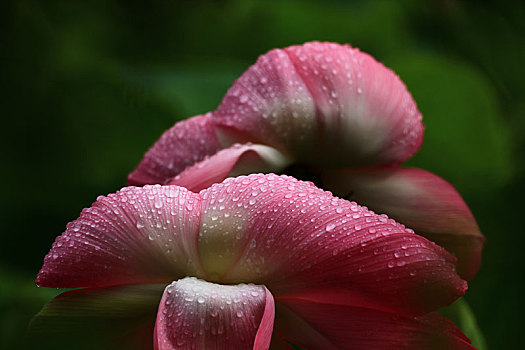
xmin=129 ymin=42 xmax=484 ymax=280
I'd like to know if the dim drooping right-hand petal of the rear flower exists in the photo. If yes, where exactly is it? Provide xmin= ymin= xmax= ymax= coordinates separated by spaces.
xmin=323 ymin=168 xmax=485 ymax=280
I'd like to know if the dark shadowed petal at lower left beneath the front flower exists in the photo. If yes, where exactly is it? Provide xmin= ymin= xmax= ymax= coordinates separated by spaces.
xmin=26 ymin=284 xmax=165 ymax=350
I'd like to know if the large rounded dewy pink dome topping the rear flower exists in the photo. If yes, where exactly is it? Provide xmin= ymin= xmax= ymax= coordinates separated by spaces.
xmin=212 ymin=42 xmax=423 ymax=167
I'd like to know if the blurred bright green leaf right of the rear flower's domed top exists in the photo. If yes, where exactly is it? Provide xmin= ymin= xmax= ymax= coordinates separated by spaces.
xmin=391 ymin=52 xmax=514 ymax=195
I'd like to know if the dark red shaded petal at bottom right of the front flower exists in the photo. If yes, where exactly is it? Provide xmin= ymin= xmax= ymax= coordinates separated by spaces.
xmin=275 ymin=300 xmax=474 ymax=350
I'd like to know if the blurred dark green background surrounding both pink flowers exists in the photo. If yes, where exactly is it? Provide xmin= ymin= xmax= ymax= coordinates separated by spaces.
xmin=0 ymin=0 xmax=525 ymax=349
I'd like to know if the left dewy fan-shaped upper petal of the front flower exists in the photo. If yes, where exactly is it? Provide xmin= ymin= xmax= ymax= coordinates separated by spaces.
xmin=36 ymin=185 xmax=202 ymax=288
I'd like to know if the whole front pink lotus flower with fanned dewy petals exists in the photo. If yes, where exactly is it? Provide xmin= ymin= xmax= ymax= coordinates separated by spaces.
xmin=37 ymin=174 xmax=472 ymax=349
